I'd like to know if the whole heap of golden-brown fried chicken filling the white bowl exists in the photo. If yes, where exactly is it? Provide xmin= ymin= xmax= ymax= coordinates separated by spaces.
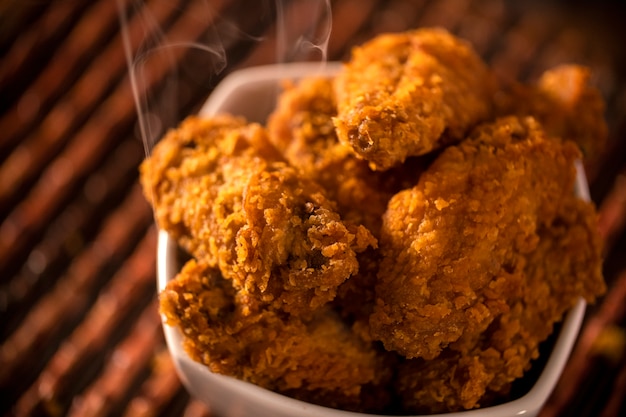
xmin=141 ymin=29 xmax=606 ymax=413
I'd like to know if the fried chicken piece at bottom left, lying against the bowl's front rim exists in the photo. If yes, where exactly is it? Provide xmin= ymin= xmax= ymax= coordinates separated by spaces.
xmin=160 ymin=259 xmax=391 ymax=411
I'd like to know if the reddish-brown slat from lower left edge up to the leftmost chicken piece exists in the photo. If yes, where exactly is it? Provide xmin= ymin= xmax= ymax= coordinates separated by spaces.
xmin=0 ymin=186 xmax=152 ymax=410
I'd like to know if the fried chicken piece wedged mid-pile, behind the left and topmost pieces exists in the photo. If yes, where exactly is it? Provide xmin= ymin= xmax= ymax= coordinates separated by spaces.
xmin=268 ymin=78 xmax=428 ymax=334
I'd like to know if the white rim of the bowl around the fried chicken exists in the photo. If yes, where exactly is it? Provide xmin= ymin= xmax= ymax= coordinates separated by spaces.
xmin=157 ymin=62 xmax=590 ymax=417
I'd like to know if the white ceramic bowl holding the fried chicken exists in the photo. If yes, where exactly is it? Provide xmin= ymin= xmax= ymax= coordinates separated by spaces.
xmin=158 ymin=63 xmax=589 ymax=417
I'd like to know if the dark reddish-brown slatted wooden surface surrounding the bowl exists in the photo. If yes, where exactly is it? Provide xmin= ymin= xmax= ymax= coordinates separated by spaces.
xmin=0 ymin=0 xmax=626 ymax=417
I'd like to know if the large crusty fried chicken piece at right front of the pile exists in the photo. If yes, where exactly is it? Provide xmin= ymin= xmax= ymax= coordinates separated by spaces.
xmin=370 ymin=117 xmax=596 ymax=359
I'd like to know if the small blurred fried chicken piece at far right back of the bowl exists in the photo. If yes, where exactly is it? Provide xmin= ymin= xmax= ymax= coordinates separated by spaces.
xmin=497 ymin=65 xmax=608 ymax=164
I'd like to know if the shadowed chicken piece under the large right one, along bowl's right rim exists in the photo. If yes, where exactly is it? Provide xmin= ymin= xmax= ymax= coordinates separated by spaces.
xmin=396 ymin=191 xmax=606 ymax=413
